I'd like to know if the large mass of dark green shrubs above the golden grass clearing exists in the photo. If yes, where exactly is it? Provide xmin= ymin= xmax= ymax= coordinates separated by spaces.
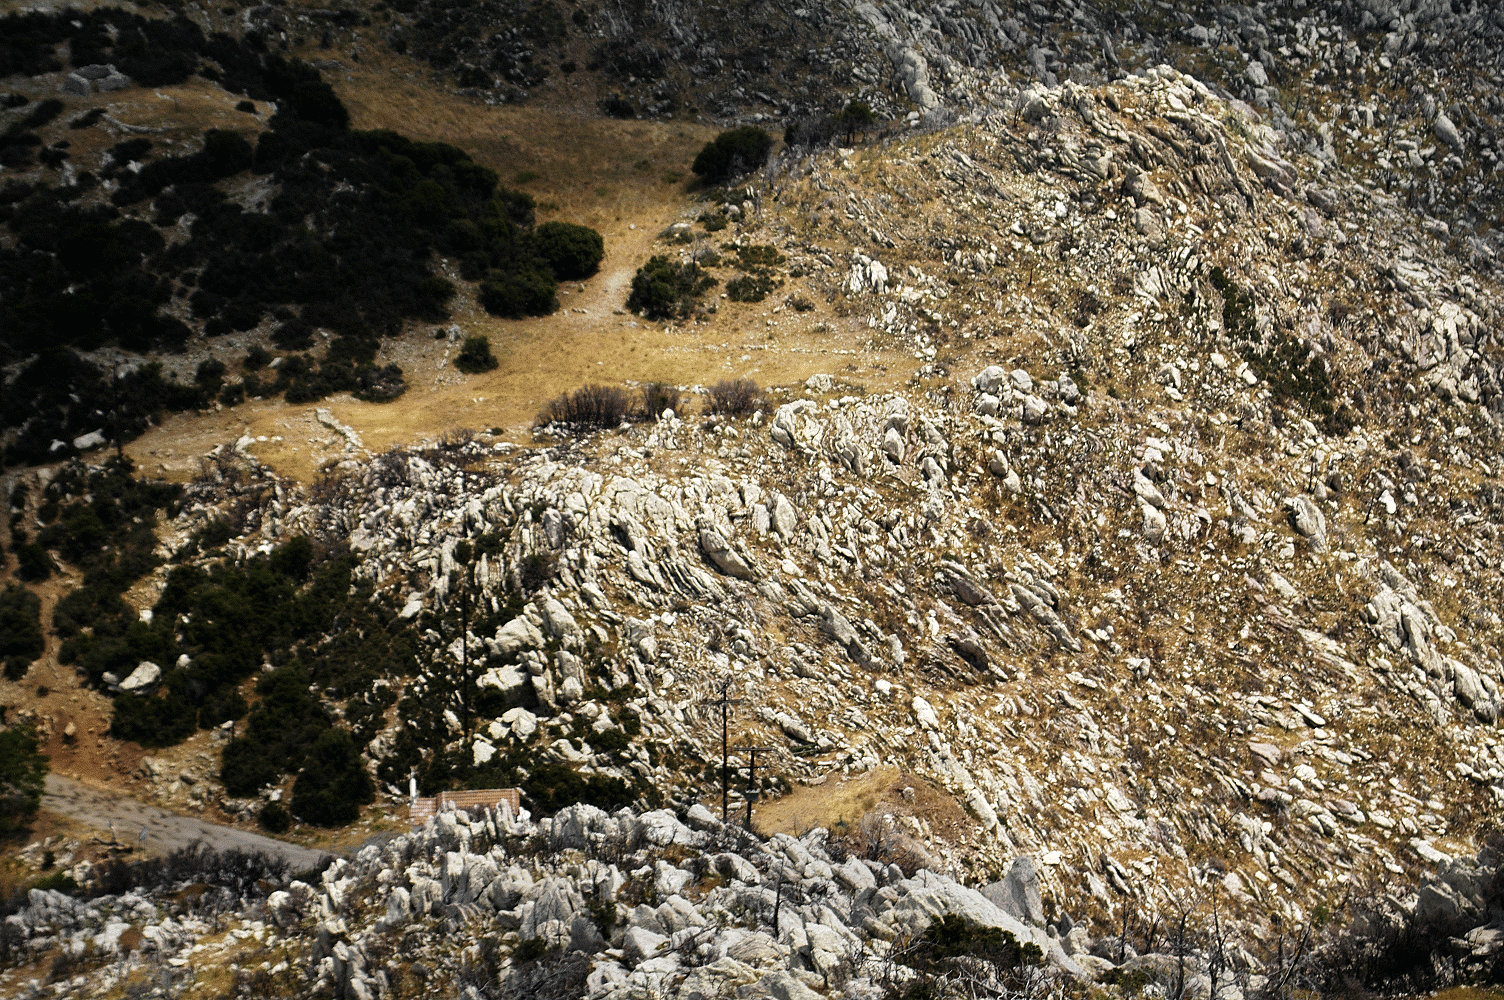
xmin=0 ymin=9 xmax=603 ymax=465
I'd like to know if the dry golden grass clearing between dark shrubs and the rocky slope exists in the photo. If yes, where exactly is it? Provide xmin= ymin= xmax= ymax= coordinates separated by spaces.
xmin=76 ymin=35 xmax=916 ymax=481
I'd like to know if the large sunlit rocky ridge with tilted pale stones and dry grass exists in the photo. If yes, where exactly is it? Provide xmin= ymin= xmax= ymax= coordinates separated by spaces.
xmin=14 ymin=44 xmax=1504 ymax=980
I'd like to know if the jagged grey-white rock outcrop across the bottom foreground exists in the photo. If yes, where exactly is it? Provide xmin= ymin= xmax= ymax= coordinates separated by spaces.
xmin=6 ymin=805 xmax=1498 ymax=998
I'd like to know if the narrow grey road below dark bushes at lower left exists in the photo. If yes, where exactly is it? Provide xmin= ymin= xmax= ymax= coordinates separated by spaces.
xmin=42 ymin=774 xmax=325 ymax=871
